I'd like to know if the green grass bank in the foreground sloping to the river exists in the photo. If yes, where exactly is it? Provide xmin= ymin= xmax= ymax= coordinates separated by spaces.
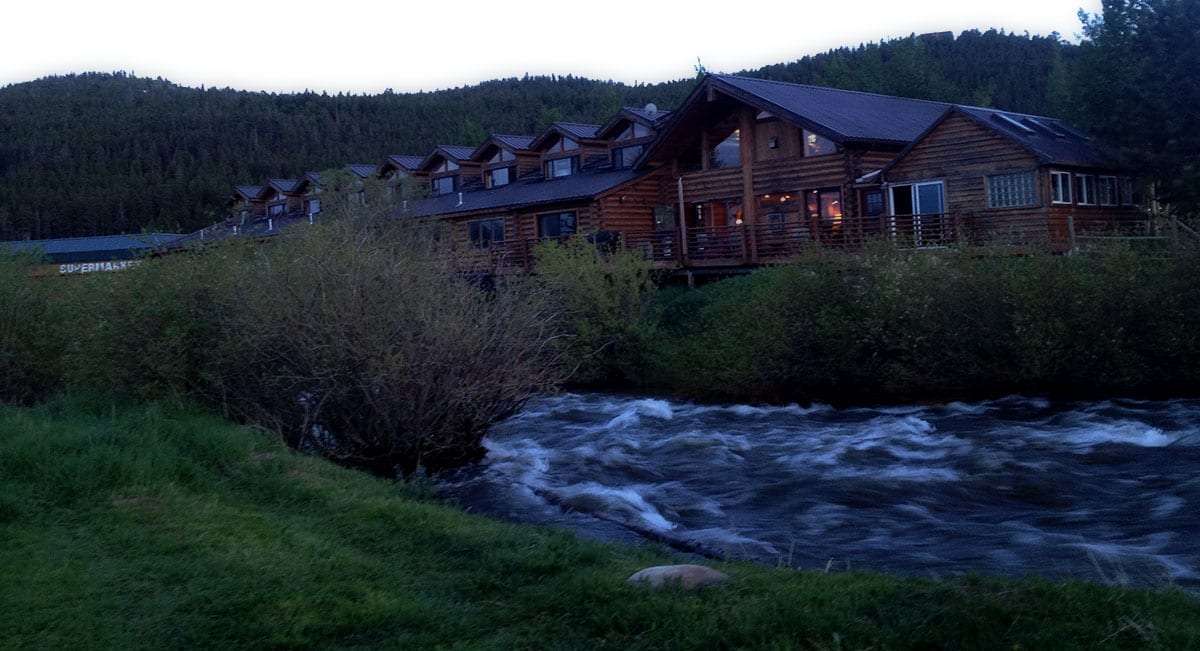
xmin=0 ymin=399 xmax=1200 ymax=649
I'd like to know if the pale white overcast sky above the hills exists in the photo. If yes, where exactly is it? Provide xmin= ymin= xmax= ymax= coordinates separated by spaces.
xmin=0 ymin=0 xmax=1099 ymax=92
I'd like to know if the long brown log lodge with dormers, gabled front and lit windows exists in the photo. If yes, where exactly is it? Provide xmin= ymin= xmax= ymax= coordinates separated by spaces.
xmin=196 ymin=74 xmax=1142 ymax=271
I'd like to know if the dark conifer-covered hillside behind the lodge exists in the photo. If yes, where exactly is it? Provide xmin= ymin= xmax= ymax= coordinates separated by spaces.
xmin=0 ymin=31 xmax=1080 ymax=239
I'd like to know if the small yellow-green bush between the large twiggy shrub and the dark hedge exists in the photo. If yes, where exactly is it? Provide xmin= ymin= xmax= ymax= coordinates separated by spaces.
xmin=535 ymin=237 xmax=654 ymax=384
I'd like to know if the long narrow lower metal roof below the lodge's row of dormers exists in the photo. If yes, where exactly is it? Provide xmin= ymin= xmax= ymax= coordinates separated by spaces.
xmin=397 ymin=169 xmax=644 ymax=217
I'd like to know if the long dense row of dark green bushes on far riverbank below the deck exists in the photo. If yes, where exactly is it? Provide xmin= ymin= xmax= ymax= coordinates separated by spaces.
xmin=643 ymin=249 xmax=1200 ymax=401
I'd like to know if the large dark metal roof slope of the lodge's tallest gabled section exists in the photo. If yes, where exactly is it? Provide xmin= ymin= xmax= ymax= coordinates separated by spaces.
xmin=708 ymin=74 xmax=950 ymax=144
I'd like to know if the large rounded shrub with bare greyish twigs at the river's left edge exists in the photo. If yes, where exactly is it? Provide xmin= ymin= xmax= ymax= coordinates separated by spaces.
xmin=205 ymin=220 xmax=559 ymax=476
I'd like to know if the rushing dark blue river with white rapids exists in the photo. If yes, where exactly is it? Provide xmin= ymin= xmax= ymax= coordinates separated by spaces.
xmin=442 ymin=394 xmax=1200 ymax=589
